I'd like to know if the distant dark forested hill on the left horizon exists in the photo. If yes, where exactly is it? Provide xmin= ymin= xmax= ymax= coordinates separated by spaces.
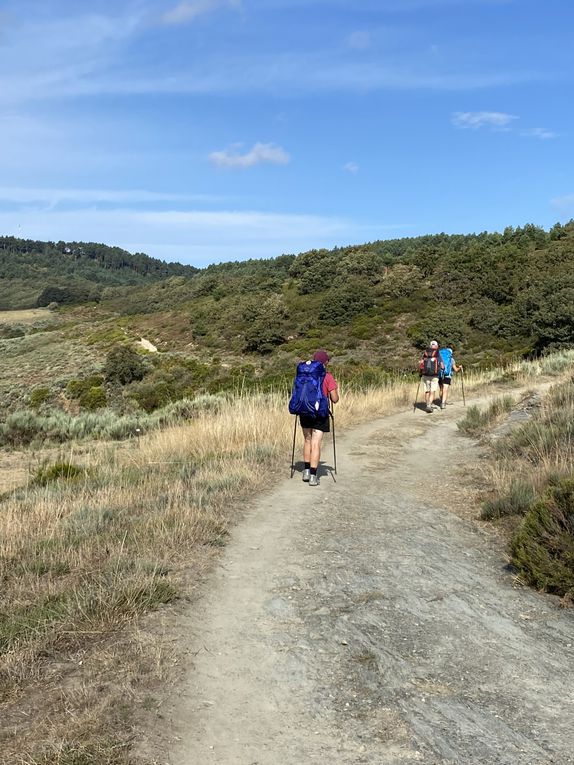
xmin=0 ymin=237 xmax=197 ymax=310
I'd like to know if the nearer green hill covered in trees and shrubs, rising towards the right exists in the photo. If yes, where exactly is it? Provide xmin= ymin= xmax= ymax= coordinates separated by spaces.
xmin=91 ymin=222 xmax=574 ymax=368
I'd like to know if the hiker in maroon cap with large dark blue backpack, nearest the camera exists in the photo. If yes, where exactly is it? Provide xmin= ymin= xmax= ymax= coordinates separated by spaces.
xmin=289 ymin=349 xmax=339 ymax=486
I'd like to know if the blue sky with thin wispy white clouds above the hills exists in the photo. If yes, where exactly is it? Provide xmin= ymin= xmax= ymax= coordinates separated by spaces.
xmin=0 ymin=0 xmax=574 ymax=266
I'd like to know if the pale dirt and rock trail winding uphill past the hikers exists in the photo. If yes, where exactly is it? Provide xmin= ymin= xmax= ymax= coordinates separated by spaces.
xmin=158 ymin=394 xmax=574 ymax=765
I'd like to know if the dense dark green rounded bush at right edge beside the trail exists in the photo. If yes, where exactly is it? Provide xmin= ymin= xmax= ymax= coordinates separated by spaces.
xmin=510 ymin=479 xmax=574 ymax=596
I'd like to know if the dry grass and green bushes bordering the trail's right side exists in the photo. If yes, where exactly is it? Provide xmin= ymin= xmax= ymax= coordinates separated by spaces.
xmin=466 ymin=352 xmax=574 ymax=605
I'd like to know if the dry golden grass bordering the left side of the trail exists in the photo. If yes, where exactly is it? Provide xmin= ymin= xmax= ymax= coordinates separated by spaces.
xmin=0 ymin=385 xmax=412 ymax=765
